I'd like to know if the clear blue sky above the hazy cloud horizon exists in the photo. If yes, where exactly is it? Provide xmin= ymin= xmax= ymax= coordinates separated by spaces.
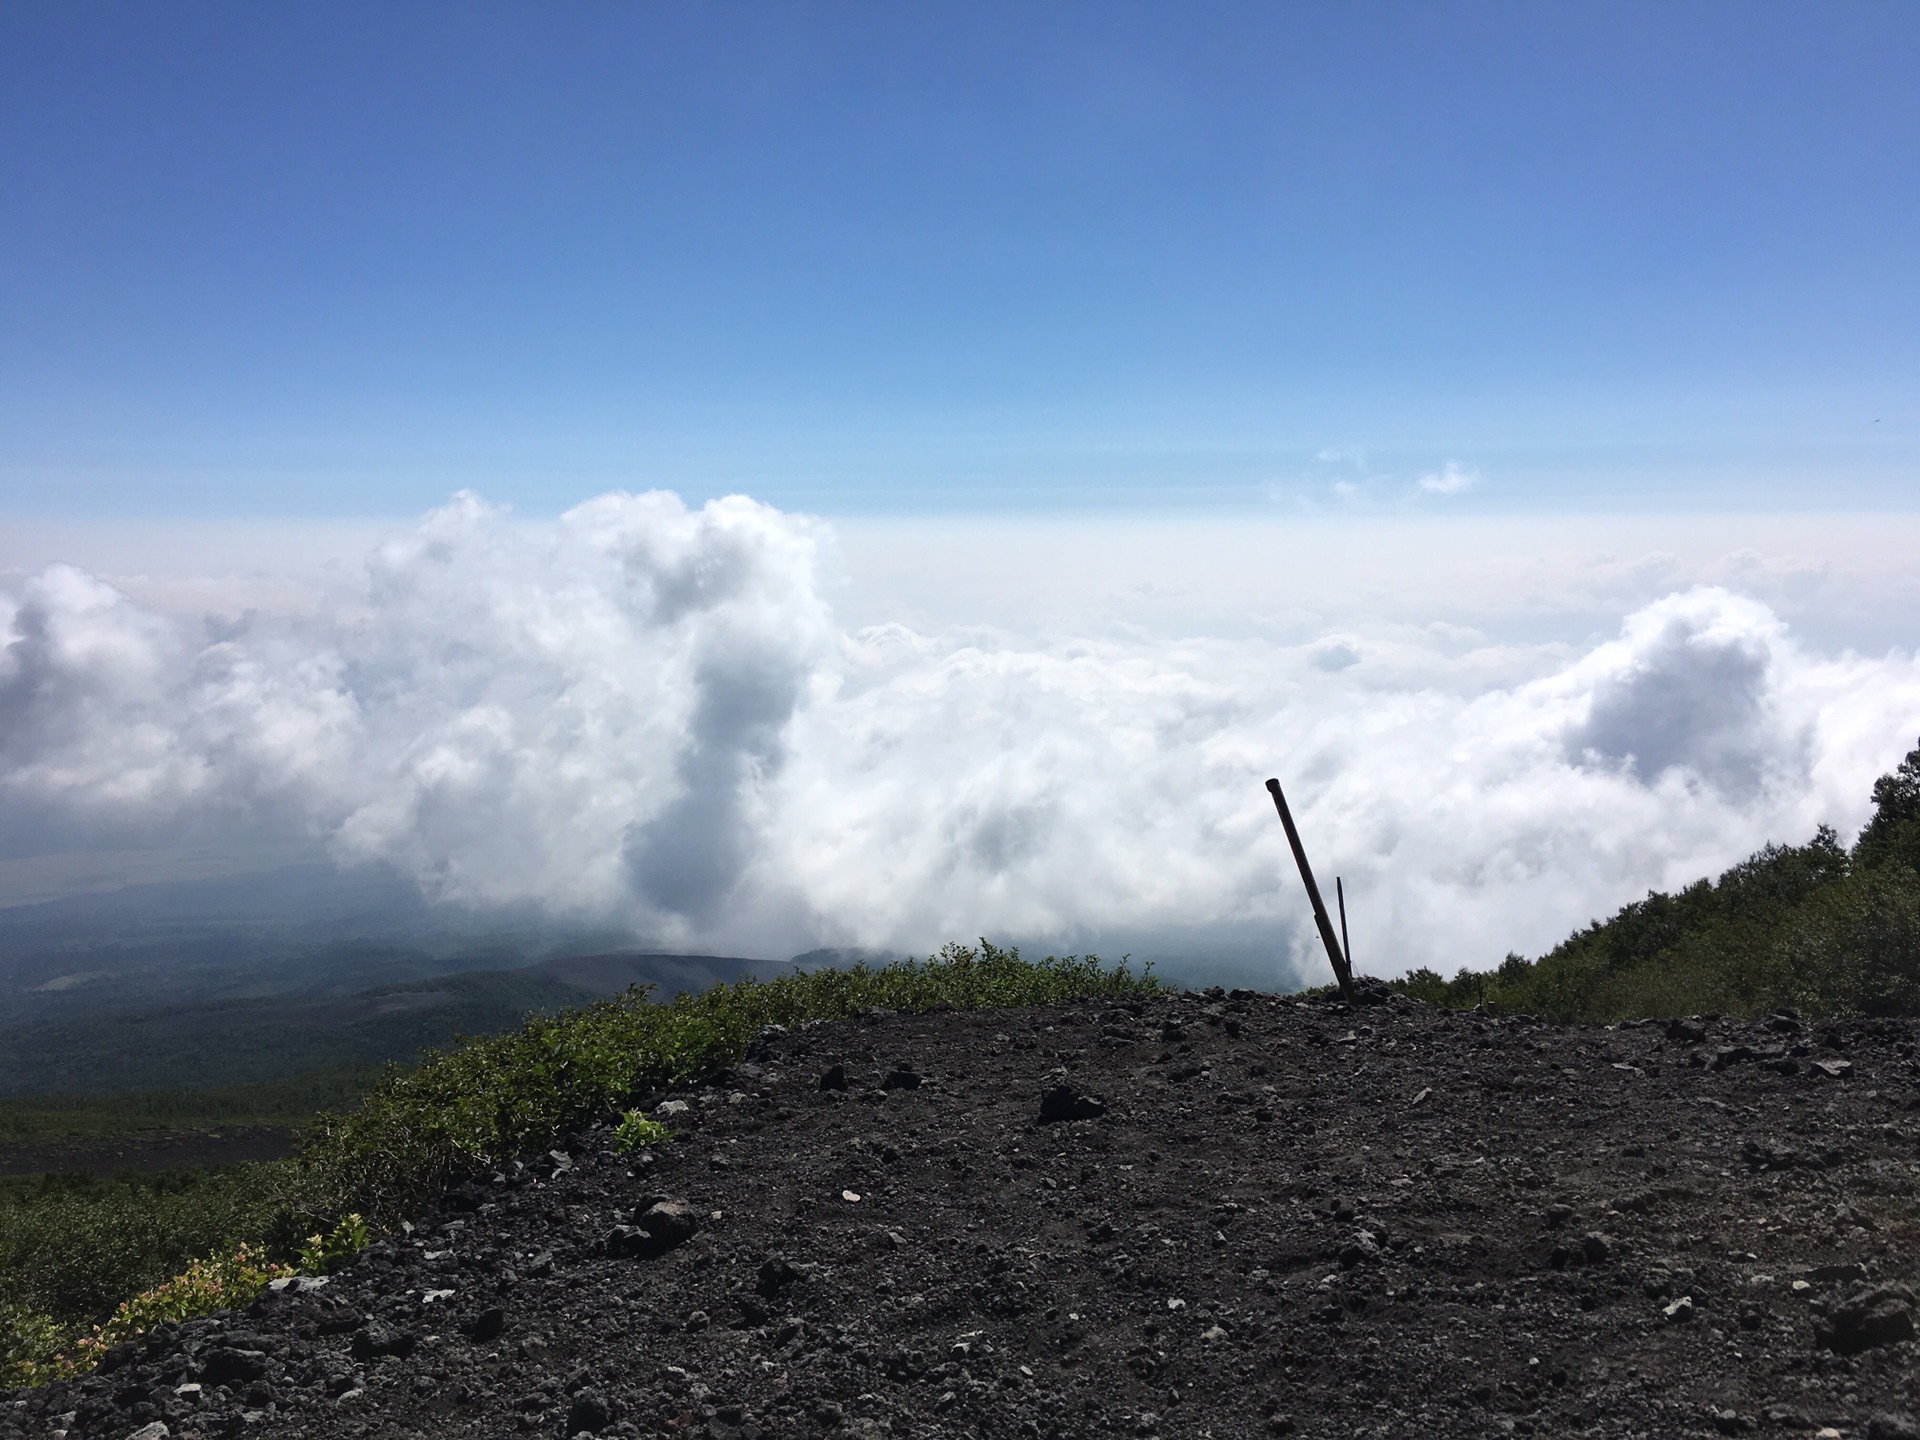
xmin=0 ymin=4 xmax=1920 ymax=520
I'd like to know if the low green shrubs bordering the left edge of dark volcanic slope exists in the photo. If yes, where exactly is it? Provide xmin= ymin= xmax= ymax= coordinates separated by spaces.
xmin=0 ymin=941 xmax=1160 ymax=1384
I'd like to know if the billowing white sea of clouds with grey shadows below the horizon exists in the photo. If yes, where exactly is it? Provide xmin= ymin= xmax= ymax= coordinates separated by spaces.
xmin=0 ymin=492 xmax=1920 ymax=977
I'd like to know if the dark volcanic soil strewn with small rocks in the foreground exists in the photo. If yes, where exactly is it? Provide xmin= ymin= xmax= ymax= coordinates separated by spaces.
xmin=11 ymin=993 xmax=1920 ymax=1440
